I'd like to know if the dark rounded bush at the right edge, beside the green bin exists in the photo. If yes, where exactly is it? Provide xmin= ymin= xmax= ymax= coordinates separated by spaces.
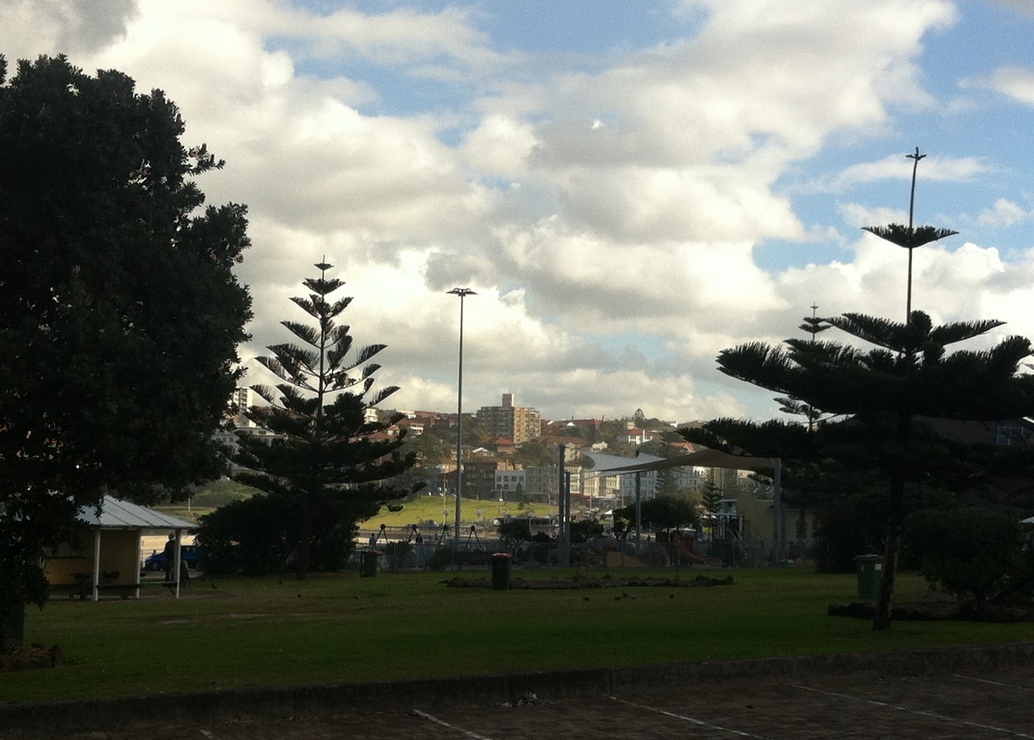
xmin=905 ymin=506 xmax=1034 ymax=603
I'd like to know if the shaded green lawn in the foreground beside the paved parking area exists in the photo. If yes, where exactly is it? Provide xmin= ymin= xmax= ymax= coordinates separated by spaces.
xmin=8 ymin=569 xmax=1034 ymax=702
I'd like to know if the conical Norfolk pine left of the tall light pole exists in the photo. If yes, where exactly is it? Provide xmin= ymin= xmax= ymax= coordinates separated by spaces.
xmin=234 ymin=264 xmax=416 ymax=579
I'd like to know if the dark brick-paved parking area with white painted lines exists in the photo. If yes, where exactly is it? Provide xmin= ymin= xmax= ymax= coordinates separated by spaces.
xmin=10 ymin=667 xmax=1034 ymax=740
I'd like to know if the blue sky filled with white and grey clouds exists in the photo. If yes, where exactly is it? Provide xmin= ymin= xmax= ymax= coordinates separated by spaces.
xmin=0 ymin=0 xmax=1034 ymax=422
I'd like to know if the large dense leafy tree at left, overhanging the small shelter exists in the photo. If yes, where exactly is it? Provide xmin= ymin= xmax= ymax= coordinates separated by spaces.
xmin=0 ymin=57 xmax=251 ymax=647
